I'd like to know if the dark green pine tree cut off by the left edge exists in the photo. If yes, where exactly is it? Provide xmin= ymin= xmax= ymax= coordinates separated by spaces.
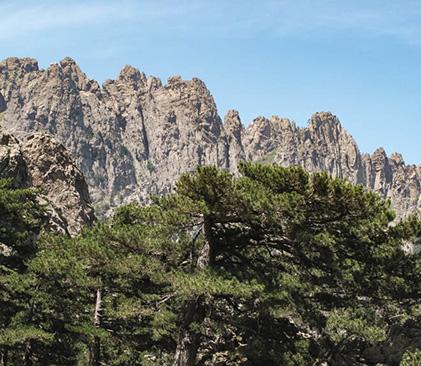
xmin=0 ymin=179 xmax=42 ymax=365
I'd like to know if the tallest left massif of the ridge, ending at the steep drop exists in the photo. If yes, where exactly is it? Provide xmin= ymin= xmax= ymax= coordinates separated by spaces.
xmin=0 ymin=58 xmax=229 ymax=214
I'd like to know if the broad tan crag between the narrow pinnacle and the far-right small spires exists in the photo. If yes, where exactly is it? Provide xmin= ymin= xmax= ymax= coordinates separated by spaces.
xmin=241 ymin=112 xmax=363 ymax=184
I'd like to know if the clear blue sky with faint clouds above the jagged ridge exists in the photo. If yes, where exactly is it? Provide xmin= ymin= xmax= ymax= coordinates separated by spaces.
xmin=0 ymin=0 xmax=421 ymax=164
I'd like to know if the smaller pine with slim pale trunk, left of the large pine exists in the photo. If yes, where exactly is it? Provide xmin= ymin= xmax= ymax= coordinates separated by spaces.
xmin=27 ymin=217 xmax=184 ymax=366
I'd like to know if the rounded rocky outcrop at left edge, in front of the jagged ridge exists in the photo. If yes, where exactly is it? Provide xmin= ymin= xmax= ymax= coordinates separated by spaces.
xmin=0 ymin=129 xmax=95 ymax=235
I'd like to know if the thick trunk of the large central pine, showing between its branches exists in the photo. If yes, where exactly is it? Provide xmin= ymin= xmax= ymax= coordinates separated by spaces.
xmin=172 ymin=216 xmax=216 ymax=366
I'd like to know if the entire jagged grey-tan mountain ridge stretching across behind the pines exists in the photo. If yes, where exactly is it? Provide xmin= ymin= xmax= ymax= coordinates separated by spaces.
xmin=0 ymin=58 xmax=421 ymax=216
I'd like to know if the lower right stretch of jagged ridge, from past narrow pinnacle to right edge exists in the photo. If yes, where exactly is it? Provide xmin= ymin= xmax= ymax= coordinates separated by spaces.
xmin=243 ymin=112 xmax=421 ymax=217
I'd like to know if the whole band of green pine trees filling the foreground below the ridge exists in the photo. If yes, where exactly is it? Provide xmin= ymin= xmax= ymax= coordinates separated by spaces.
xmin=0 ymin=163 xmax=421 ymax=366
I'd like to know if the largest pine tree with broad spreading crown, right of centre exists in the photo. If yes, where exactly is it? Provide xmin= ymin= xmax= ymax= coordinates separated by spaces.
xmin=120 ymin=163 xmax=419 ymax=366
